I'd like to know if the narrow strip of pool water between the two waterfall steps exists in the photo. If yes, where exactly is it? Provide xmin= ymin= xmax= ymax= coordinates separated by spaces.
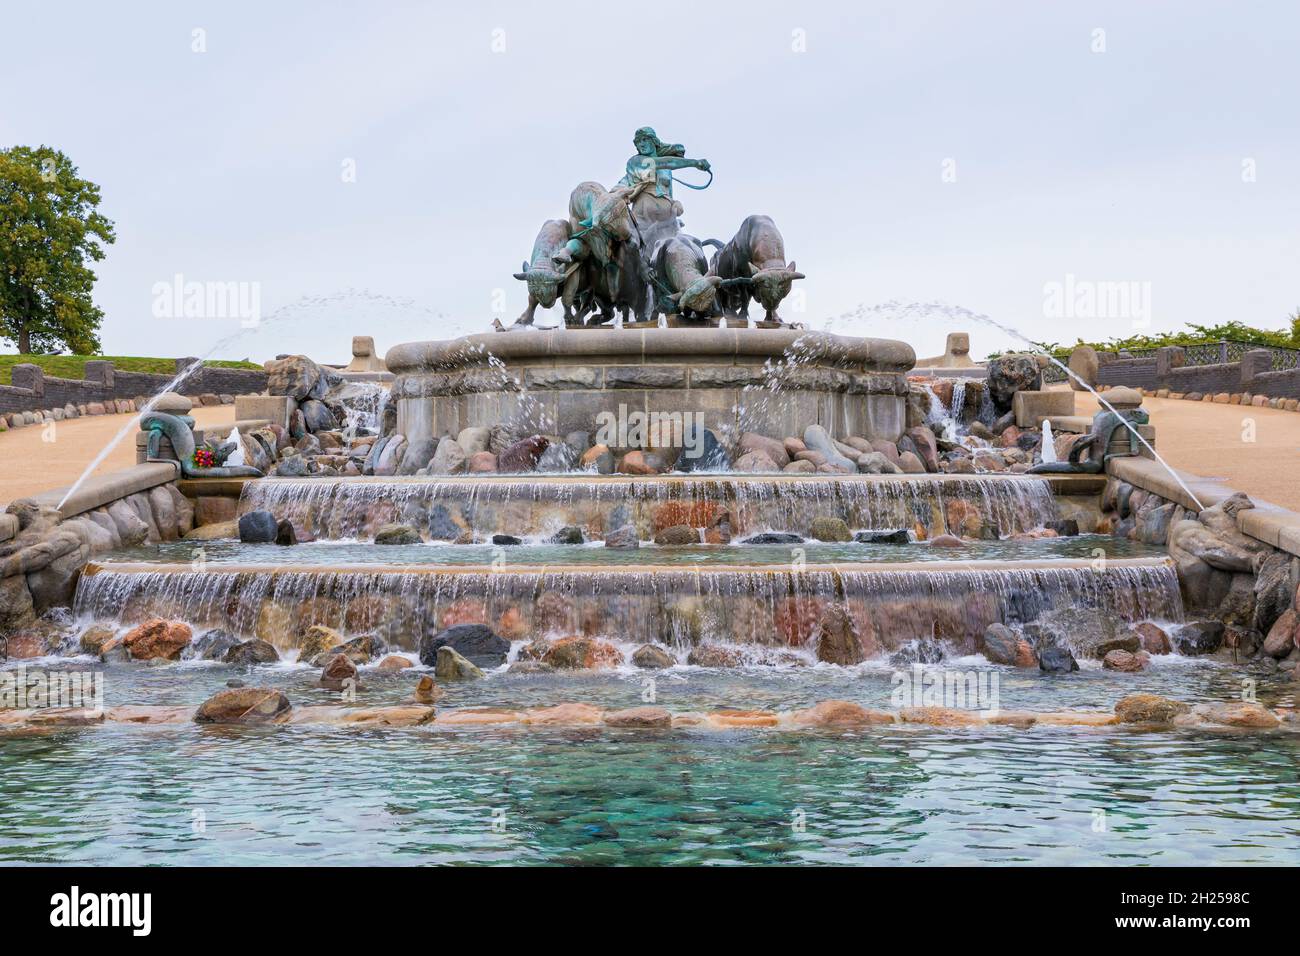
xmin=95 ymin=535 xmax=1165 ymax=567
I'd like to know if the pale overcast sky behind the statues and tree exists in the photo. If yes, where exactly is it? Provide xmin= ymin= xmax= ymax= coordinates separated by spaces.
xmin=0 ymin=0 xmax=1300 ymax=360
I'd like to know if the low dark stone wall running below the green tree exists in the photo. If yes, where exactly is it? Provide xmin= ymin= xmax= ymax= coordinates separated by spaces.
xmin=0 ymin=359 xmax=267 ymax=414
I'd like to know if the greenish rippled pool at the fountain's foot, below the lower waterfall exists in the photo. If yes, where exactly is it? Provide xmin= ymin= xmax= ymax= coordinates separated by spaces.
xmin=0 ymin=658 xmax=1300 ymax=865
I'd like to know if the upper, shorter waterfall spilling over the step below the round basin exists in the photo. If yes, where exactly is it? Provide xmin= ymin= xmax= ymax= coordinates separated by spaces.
xmin=239 ymin=475 xmax=1060 ymax=538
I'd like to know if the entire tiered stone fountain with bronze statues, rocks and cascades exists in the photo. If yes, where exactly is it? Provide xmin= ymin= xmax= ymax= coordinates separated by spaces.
xmin=0 ymin=130 xmax=1294 ymax=861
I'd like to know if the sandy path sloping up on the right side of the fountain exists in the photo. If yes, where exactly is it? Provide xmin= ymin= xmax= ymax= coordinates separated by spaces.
xmin=1074 ymin=392 xmax=1300 ymax=511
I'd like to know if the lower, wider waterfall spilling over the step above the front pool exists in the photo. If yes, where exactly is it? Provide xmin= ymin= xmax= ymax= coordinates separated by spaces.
xmin=75 ymin=558 xmax=1182 ymax=653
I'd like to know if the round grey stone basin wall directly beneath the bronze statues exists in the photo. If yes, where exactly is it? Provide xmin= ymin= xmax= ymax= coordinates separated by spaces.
xmin=386 ymin=329 xmax=915 ymax=441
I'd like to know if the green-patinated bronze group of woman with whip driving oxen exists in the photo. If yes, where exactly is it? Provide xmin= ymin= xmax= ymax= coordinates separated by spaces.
xmin=504 ymin=126 xmax=803 ymax=329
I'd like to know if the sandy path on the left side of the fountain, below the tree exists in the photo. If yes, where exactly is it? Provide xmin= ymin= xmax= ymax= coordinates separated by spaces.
xmin=0 ymin=405 xmax=235 ymax=510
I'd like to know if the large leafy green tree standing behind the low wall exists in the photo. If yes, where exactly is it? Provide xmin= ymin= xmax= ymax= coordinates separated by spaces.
xmin=0 ymin=146 xmax=114 ymax=355
